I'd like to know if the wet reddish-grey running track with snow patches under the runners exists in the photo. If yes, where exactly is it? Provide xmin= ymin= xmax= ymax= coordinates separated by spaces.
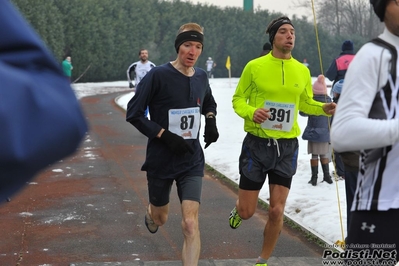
xmin=0 ymin=92 xmax=323 ymax=266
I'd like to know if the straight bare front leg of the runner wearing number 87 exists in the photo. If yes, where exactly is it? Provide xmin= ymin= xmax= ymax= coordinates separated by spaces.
xmin=181 ymin=200 xmax=201 ymax=266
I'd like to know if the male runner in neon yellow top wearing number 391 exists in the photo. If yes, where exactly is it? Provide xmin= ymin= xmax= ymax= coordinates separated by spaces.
xmin=229 ymin=17 xmax=335 ymax=266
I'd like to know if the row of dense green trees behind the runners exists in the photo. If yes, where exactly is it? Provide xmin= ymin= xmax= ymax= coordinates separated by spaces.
xmin=12 ymin=0 xmax=380 ymax=82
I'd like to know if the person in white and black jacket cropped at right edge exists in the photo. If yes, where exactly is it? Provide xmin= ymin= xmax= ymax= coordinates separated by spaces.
xmin=331 ymin=0 xmax=399 ymax=265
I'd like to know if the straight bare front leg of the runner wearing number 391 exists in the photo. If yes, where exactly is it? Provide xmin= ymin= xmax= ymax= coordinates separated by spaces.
xmin=261 ymin=184 xmax=290 ymax=259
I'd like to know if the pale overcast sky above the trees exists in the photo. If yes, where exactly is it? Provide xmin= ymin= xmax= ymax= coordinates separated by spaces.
xmin=185 ymin=0 xmax=312 ymax=17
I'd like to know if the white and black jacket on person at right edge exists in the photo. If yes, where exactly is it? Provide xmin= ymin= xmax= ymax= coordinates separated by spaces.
xmin=331 ymin=29 xmax=399 ymax=211
